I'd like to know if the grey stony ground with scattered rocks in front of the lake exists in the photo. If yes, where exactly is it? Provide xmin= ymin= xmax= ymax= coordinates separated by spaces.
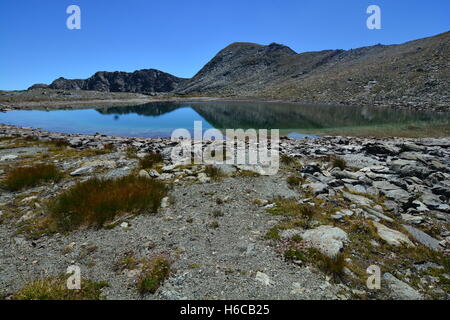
xmin=0 ymin=126 xmax=450 ymax=299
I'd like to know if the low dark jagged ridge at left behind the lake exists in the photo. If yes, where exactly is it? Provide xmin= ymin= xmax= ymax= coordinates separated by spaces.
xmin=30 ymin=69 xmax=185 ymax=94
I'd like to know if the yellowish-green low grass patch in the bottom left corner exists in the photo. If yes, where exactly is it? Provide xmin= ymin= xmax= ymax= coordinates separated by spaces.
xmin=12 ymin=276 xmax=108 ymax=300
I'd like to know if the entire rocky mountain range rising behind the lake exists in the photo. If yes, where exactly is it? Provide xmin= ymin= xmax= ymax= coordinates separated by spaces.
xmin=32 ymin=32 xmax=450 ymax=108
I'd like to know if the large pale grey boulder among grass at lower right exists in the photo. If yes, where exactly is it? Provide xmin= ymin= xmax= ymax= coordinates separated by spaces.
xmin=302 ymin=226 xmax=348 ymax=258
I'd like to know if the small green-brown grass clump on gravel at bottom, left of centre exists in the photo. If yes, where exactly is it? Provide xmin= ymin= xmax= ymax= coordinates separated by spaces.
xmin=137 ymin=256 xmax=171 ymax=294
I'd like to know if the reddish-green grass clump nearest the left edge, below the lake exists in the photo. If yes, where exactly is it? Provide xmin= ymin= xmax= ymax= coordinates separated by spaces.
xmin=4 ymin=164 xmax=63 ymax=191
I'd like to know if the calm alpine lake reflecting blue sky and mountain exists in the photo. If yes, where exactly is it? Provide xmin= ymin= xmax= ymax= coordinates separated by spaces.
xmin=0 ymin=102 xmax=450 ymax=138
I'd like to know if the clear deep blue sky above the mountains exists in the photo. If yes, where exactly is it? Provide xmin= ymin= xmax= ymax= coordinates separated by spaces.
xmin=0 ymin=0 xmax=450 ymax=90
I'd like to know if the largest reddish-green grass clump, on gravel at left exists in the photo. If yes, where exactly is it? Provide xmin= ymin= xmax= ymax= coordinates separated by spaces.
xmin=49 ymin=175 xmax=167 ymax=231
